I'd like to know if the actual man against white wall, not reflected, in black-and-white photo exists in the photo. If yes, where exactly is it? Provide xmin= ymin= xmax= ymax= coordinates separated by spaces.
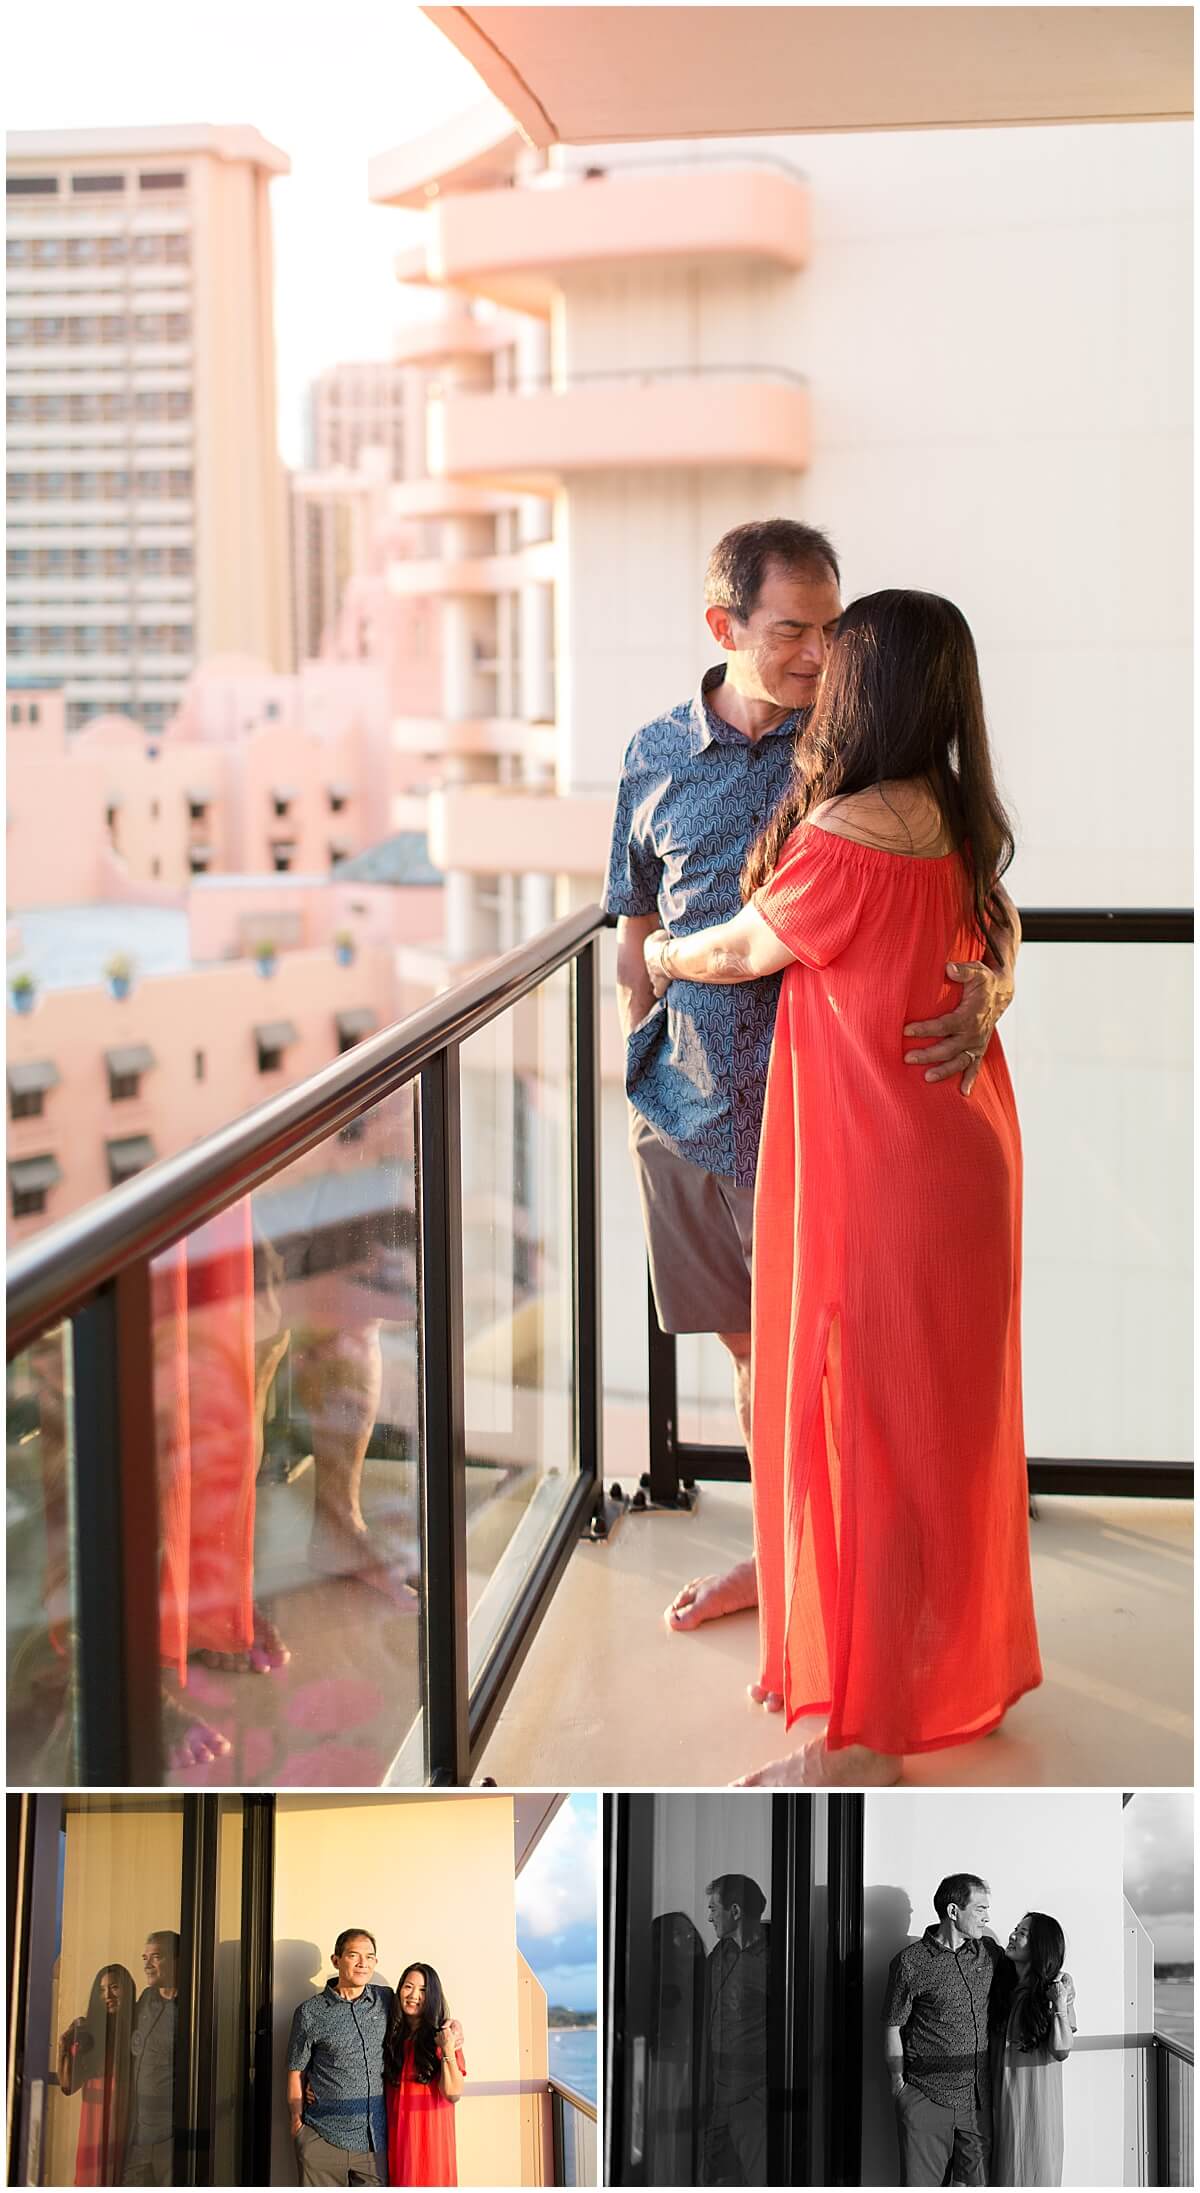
xmin=884 ymin=1873 xmax=1003 ymax=2186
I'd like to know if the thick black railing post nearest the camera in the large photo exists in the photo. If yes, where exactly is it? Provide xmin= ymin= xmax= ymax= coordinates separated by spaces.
xmin=64 ymin=1257 xmax=162 ymax=1787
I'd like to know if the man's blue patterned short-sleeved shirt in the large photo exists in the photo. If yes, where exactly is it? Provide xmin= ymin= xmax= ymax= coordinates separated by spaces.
xmin=603 ymin=664 xmax=803 ymax=1189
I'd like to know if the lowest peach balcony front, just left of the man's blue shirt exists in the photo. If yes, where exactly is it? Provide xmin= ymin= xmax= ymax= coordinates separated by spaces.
xmin=428 ymin=785 xmax=612 ymax=875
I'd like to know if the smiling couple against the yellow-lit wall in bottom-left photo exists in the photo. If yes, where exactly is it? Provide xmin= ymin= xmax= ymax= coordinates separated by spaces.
xmin=287 ymin=1928 xmax=467 ymax=2186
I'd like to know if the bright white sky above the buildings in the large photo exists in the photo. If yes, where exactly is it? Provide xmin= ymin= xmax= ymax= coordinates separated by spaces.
xmin=4 ymin=0 xmax=487 ymax=465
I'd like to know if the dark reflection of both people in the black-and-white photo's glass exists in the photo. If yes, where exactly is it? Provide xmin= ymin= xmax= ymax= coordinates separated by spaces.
xmin=647 ymin=1873 xmax=768 ymax=2186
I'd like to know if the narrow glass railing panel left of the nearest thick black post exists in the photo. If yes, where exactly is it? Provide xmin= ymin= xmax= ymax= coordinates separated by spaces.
xmin=4 ymin=1325 xmax=77 ymax=1787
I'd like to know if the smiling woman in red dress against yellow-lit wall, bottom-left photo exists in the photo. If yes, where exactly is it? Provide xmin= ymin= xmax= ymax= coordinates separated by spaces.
xmin=384 ymin=1965 xmax=467 ymax=2186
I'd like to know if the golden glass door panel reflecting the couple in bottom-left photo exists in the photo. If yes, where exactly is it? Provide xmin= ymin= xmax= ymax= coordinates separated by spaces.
xmin=35 ymin=1796 xmax=182 ymax=2186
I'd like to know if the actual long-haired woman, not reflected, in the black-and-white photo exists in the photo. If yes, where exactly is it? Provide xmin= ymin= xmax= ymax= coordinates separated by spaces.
xmin=989 ymin=1912 xmax=1075 ymax=2186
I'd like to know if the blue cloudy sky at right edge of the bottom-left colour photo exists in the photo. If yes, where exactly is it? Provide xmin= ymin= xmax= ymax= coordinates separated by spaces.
xmin=518 ymin=1792 xmax=597 ymax=2011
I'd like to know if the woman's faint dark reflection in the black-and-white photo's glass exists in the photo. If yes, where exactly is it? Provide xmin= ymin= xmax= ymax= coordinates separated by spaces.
xmin=647 ymin=1912 xmax=704 ymax=2186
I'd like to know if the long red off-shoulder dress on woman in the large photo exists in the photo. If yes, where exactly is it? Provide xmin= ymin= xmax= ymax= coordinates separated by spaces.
xmin=752 ymin=827 xmax=1042 ymax=1754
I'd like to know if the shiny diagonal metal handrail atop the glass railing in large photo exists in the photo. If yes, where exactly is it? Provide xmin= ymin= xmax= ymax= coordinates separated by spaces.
xmin=7 ymin=906 xmax=608 ymax=1355
